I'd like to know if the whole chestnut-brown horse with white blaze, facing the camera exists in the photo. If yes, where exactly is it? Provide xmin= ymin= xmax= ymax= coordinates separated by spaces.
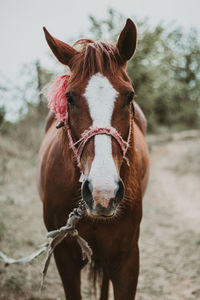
xmin=38 ymin=19 xmax=149 ymax=300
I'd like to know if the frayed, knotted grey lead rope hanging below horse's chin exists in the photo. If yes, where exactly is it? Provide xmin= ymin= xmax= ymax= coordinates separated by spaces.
xmin=0 ymin=200 xmax=92 ymax=288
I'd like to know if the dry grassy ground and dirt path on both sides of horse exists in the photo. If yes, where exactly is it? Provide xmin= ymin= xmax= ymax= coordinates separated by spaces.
xmin=0 ymin=132 xmax=200 ymax=300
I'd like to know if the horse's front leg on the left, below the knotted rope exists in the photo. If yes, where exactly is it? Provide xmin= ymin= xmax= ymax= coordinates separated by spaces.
xmin=54 ymin=241 xmax=82 ymax=300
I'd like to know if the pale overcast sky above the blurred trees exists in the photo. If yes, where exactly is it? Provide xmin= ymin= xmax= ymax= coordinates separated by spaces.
xmin=0 ymin=0 xmax=200 ymax=119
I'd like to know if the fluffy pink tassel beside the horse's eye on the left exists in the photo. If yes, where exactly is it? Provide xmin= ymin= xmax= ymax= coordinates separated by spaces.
xmin=42 ymin=75 xmax=69 ymax=122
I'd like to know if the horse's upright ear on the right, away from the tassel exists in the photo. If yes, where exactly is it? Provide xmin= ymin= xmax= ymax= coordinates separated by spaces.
xmin=117 ymin=19 xmax=137 ymax=64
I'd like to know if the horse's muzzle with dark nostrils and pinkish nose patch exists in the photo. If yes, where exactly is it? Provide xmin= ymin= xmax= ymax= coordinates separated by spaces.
xmin=82 ymin=179 xmax=124 ymax=218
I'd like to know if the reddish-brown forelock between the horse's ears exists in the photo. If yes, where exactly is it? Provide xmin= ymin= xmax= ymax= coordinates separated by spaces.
xmin=69 ymin=39 xmax=120 ymax=81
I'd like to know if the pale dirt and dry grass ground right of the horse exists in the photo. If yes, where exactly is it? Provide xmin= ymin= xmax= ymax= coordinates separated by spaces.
xmin=137 ymin=139 xmax=200 ymax=300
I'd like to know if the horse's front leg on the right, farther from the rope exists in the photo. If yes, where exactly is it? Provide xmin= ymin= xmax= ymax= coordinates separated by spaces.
xmin=111 ymin=245 xmax=139 ymax=300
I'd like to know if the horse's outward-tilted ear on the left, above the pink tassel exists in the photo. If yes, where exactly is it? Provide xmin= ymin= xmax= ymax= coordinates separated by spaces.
xmin=43 ymin=27 xmax=77 ymax=67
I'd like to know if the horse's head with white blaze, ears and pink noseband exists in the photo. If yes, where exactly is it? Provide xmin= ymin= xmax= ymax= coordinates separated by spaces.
xmin=44 ymin=19 xmax=137 ymax=218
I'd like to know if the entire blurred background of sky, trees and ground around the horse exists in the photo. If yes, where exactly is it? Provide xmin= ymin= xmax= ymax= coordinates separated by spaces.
xmin=0 ymin=0 xmax=200 ymax=300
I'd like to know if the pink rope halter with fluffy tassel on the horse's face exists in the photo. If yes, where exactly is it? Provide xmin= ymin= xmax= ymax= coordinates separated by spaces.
xmin=42 ymin=75 xmax=132 ymax=171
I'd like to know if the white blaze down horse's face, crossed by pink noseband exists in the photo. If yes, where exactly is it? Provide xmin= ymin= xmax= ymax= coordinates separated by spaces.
xmin=84 ymin=73 xmax=118 ymax=199
